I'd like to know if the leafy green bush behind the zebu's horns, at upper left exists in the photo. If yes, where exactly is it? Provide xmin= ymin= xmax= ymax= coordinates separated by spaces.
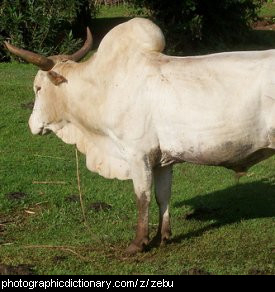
xmin=0 ymin=0 xmax=95 ymax=61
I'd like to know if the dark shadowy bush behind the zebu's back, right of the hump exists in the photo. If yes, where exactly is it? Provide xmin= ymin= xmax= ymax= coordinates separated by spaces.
xmin=132 ymin=0 xmax=266 ymax=51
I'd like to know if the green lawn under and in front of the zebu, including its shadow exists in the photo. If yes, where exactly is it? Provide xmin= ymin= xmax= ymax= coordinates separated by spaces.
xmin=0 ymin=63 xmax=275 ymax=274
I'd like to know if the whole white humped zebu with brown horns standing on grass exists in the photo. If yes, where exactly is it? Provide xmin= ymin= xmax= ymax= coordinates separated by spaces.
xmin=6 ymin=18 xmax=275 ymax=253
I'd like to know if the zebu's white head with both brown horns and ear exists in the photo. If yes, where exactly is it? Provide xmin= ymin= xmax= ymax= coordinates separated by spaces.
xmin=5 ymin=28 xmax=93 ymax=135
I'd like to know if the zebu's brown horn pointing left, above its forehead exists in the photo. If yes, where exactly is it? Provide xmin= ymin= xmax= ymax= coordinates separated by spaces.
xmin=4 ymin=42 xmax=55 ymax=71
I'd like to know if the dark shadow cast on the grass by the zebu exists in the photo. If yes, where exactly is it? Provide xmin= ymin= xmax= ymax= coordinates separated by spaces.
xmin=170 ymin=177 xmax=275 ymax=243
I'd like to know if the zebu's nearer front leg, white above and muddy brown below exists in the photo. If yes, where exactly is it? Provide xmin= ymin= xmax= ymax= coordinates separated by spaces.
xmin=126 ymin=156 xmax=152 ymax=254
